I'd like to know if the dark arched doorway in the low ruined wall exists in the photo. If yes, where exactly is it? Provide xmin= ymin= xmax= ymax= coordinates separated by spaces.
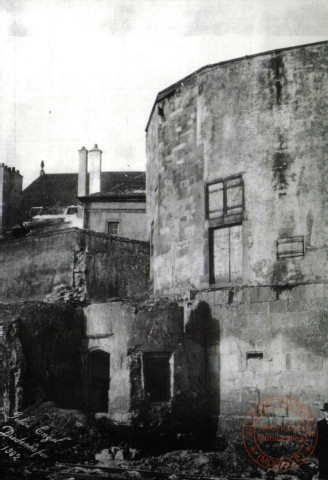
xmin=87 ymin=349 xmax=110 ymax=412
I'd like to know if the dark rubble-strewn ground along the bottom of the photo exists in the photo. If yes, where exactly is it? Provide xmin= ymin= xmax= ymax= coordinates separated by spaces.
xmin=0 ymin=402 xmax=318 ymax=480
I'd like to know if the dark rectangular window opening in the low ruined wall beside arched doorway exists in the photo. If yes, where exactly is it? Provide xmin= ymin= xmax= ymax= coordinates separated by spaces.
xmin=143 ymin=352 xmax=171 ymax=402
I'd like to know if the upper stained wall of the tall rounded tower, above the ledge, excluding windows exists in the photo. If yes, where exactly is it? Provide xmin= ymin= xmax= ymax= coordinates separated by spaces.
xmin=147 ymin=43 xmax=327 ymax=294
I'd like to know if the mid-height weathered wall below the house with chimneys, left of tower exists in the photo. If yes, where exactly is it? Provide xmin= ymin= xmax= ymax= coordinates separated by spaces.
xmin=0 ymin=229 xmax=148 ymax=302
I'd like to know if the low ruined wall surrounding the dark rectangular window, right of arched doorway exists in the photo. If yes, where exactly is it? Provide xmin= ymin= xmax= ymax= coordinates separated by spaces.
xmin=84 ymin=300 xmax=208 ymax=430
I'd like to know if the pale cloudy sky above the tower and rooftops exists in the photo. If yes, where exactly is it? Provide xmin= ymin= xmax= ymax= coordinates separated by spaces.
xmin=0 ymin=0 xmax=328 ymax=186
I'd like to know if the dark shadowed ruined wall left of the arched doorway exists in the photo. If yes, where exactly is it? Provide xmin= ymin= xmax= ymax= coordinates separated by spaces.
xmin=0 ymin=302 xmax=83 ymax=414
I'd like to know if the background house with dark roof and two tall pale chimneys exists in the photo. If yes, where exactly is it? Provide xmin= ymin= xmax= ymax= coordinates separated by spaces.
xmin=23 ymin=145 xmax=148 ymax=241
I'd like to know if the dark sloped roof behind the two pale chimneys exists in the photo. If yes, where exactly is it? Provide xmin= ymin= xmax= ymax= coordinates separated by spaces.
xmin=23 ymin=172 xmax=146 ymax=214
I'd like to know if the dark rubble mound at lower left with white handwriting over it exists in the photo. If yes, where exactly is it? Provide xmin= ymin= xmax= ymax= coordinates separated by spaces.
xmin=0 ymin=402 xmax=109 ymax=466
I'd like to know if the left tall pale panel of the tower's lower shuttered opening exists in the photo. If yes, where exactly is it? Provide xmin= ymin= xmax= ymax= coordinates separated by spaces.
xmin=213 ymin=228 xmax=229 ymax=283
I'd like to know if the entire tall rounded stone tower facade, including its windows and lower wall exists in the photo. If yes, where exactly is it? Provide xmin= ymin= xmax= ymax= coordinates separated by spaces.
xmin=146 ymin=42 xmax=328 ymax=430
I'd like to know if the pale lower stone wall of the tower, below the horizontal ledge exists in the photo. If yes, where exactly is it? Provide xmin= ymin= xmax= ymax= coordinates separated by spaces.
xmin=190 ymin=284 xmax=328 ymax=431
